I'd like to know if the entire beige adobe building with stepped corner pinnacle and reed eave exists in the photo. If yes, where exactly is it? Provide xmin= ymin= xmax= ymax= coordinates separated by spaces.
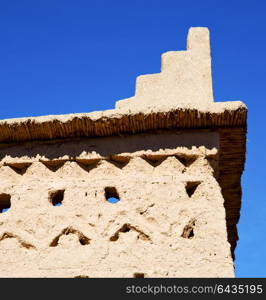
xmin=0 ymin=28 xmax=247 ymax=277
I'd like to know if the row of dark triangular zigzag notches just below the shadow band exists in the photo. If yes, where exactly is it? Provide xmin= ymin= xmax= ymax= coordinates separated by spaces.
xmin=0 ymin=154 xmax=210 ymax=175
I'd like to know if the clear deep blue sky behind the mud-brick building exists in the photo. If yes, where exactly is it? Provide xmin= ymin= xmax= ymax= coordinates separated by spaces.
xmin=0 ymin=0 xmax=266 ymax=277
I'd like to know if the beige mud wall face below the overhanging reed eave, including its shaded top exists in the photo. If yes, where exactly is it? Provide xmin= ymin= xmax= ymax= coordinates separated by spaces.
xmin=0 ymin=131 xmax=237 ymax=277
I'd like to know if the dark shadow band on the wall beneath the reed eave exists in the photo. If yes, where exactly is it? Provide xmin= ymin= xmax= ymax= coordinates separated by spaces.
xmin=0 ymin=130 xmax=219 ymax=160
